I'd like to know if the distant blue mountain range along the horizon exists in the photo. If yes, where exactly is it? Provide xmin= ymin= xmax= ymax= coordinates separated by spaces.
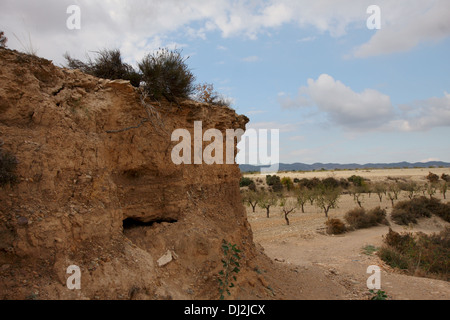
xmin=239 ymin=161 xmax=450 ymax=172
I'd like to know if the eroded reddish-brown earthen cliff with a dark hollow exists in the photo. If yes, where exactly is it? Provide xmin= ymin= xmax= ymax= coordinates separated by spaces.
xmin=0 ymin=49 xmax=265 ymax=299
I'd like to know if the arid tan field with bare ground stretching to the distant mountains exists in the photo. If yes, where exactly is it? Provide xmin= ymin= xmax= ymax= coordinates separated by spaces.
xmin=245 ymin=168 xmax=450 ymax=300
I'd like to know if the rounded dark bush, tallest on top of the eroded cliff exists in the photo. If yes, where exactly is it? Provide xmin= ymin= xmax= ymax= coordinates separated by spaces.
xmin=138 ymin=49 xmax=195 ymax=102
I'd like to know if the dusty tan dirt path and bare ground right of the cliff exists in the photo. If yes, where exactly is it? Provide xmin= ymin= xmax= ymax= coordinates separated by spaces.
xmin=248 ymin=190 xmax=450 ymax=300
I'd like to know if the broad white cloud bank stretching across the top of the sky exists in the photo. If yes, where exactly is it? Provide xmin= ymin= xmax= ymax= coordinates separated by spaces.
xmin=0 ymin=0 xmax=450 ymax=63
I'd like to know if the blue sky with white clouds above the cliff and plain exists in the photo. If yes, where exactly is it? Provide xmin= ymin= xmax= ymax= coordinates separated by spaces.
xmin=0 ymin=0 xmax=450 ymax=164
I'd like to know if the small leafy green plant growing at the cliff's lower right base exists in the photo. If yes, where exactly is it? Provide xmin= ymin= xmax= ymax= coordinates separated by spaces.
xmin=218 ymin=240 xmax=241 ymax=300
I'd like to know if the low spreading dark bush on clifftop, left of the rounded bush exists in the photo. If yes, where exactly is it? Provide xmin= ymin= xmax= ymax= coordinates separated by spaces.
xmin=64 ymin=49 xmax=142 ymax=87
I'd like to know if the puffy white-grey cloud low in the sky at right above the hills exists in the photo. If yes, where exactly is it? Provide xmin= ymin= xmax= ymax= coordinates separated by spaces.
xmin=278 ymin=74 xmax=450 ymax=132
